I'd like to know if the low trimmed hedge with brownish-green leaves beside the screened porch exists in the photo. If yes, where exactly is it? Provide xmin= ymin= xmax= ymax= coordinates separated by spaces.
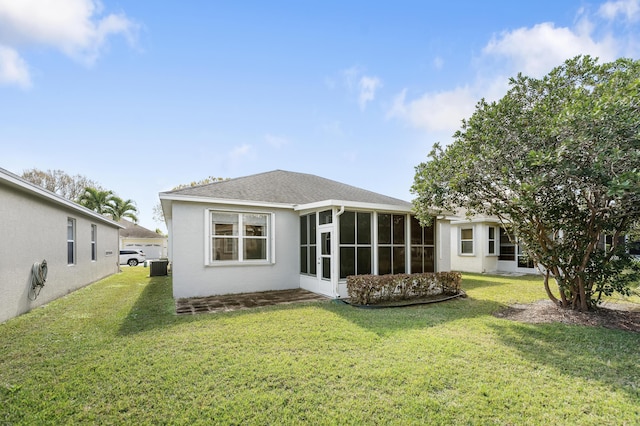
xmin=347 ymin=272 xmax=462 ymax=305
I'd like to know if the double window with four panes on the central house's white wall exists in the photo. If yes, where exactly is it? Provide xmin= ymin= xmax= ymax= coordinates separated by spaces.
xmin=209 ymin=211 xmax=271 ymax=263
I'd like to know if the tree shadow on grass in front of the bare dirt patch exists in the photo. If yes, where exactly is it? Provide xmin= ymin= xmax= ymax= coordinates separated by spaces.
xmin=492 ymin=322 xmax=640 ymax=398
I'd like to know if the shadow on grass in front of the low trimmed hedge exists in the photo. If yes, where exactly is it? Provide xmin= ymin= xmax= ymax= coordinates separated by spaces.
xmin=322 ymin=297 xmax=504 ymax=337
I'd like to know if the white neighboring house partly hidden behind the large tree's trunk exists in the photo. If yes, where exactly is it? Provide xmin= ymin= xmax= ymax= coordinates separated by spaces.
xmin=451 ymin=215 xmax=538 ymax=274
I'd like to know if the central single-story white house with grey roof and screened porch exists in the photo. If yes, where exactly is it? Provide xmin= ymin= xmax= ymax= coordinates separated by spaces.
xmin=160 ymin=170 xmax=450 ymax=298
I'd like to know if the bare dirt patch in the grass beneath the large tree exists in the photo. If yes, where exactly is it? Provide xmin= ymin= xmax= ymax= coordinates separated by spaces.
xmin=494 ymin=300 xmax=640 ymax=333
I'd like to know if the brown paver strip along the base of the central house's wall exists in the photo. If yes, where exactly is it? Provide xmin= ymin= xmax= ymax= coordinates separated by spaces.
xmin=176 ymin=288 xmax=330 ymax=315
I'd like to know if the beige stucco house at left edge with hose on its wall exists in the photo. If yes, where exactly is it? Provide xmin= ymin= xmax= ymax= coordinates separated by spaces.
xmin=0 ymin=169 xmax=120 ymax=322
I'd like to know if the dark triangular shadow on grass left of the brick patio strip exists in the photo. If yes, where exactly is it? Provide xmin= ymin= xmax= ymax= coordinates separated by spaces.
xmin=119 ymin=276 xmax=177 ymax=335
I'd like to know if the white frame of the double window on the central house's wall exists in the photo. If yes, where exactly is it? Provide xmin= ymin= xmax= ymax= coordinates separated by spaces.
xmin=204 ymin=209 xmax=275 ymax=266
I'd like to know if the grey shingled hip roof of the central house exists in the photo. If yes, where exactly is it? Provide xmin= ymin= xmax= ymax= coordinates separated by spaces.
xmin=162 ymin=170 xmax=411 ymax=208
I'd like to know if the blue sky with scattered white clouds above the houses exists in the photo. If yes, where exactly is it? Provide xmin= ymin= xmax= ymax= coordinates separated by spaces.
xmin=0 ymin=0 xmax=640 ymax=230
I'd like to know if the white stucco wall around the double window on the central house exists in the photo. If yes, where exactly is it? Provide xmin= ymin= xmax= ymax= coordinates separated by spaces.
xmin=168 ymin=201 xmax=300 ymax=298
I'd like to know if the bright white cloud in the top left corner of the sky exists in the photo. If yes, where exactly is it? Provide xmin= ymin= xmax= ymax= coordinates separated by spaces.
xmin=0 ymin=0 xmax=138 ymax=86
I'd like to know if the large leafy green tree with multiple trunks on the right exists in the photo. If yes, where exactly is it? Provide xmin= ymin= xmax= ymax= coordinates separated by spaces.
xmin=412 ymin=56 xmax=640 ymax=311
